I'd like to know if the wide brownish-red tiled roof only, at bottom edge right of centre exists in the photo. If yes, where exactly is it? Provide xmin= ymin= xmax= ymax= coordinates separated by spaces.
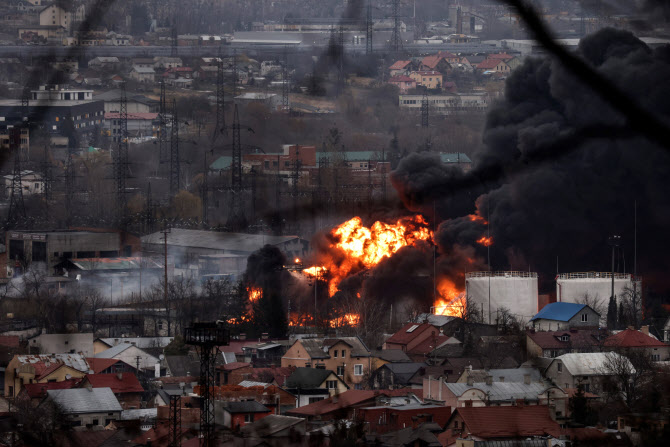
xmin=452 ymin=405 xmax=561 ymax=439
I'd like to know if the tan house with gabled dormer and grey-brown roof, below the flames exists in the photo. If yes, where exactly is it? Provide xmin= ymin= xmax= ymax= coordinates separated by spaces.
xmin=281 ymin=337 xmax=372 ymax=388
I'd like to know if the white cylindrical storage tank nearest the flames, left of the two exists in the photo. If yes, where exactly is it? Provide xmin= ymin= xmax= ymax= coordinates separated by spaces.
xmin=465 ymin=272 xmax=538 ymax=324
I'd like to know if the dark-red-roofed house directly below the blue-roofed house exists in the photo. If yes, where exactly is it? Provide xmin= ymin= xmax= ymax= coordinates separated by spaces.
xmin=526 ymin=328 xmax=607 ymax=358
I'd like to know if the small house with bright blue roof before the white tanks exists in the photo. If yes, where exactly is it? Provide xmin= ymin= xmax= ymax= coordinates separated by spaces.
xmin=530 ymin=302 xmax=600 ymax=331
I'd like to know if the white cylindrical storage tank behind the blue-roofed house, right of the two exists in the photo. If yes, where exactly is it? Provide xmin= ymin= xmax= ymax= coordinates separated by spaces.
xmin=556 ymin=272 xmax=642 ymax=319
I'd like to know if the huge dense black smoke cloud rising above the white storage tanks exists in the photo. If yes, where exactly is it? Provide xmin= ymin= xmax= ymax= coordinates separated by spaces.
xmin=392 ymin=29 xmax=670 ymax=291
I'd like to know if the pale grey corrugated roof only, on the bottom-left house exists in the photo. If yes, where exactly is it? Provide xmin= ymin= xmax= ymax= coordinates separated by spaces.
xmin=47 ymin=388 xmax=123 ymax=414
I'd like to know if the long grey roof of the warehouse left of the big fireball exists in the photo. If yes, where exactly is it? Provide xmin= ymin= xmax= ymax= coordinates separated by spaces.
xmin=142 ymin=228 xmax=300 ymax=253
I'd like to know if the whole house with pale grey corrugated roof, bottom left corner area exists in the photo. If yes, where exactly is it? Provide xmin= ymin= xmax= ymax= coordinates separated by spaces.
xmin=45 ymin=387 xmax=123 ymax=427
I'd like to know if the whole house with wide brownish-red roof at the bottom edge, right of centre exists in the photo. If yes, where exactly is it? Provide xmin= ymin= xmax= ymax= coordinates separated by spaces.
xmin=438 ymin=405 xmax=562 ymax=446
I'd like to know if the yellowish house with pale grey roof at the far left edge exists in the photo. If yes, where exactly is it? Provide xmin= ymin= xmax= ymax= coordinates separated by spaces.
xmin=5 ymin=354 xmax=90 ymax=397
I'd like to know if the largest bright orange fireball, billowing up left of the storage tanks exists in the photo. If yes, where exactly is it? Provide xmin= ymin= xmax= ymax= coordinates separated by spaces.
xmin=303 ymin=215 xmax=433 ymax=296
